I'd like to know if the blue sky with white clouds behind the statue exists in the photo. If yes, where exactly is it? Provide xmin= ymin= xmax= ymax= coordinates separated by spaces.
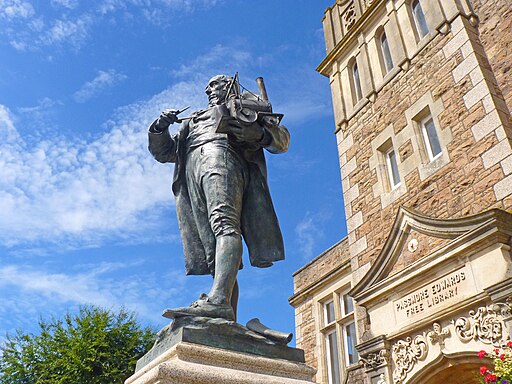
xmin=0 ymin=0 xmax=346 ymax=337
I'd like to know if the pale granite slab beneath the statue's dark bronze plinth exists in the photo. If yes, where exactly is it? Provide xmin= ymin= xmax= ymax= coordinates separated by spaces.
xmin=125 ymin=342 xmax=315 ymax=384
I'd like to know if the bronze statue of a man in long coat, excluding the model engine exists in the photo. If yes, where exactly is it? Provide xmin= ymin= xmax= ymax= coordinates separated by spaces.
xmin=149 ymin=75 xmax=290 ymax=320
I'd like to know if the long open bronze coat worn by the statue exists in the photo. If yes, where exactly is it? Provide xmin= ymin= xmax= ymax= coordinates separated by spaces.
xmin=148 ymin=115 xmax=290 ymax=275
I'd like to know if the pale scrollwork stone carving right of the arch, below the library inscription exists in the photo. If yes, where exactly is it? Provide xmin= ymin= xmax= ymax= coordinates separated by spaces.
xmin=452 ymin=303 xmax=512 ymax=346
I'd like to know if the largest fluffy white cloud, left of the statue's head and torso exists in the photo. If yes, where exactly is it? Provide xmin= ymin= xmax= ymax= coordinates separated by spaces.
xmin=0 ymin=79 xmax=208 ymax=247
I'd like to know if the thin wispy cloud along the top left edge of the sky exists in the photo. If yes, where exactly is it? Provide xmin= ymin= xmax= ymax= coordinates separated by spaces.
xmin=0 ymin=0 xmax=222 ymax=51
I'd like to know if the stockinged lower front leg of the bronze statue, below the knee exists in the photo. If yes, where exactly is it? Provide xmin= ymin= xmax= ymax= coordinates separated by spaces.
xmin=208 ymin=235 xmax=243 ymax=304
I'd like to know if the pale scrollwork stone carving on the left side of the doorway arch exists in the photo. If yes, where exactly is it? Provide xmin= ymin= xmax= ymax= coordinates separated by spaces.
xmin=391 ymin=334 xmax=428 ymax=384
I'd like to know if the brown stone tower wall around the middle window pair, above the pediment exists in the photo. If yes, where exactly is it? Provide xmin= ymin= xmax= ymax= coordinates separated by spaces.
xmin=338 ymin=11 xmax=512 ymax=282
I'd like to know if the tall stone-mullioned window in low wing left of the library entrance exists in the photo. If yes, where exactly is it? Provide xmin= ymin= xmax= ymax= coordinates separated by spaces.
xmin=321 ymin=292 xmax=359 ymax=384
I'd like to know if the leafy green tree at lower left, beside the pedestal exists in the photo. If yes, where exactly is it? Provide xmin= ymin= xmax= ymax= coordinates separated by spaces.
xmin=0 ymin=306 xmax=155 ymax=384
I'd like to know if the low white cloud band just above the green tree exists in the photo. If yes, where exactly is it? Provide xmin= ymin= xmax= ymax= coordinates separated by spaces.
xmin=0 ymin=262 xmax=186 ymax=321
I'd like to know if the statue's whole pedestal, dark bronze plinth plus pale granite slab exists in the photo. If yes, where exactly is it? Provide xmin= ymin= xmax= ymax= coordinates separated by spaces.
xmin=125 ymin=318 xmax=315 ymax=384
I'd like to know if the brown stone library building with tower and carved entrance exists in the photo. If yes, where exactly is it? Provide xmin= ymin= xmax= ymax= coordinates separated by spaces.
xmin=290 ymin=0 xmax=512 ymax=384
